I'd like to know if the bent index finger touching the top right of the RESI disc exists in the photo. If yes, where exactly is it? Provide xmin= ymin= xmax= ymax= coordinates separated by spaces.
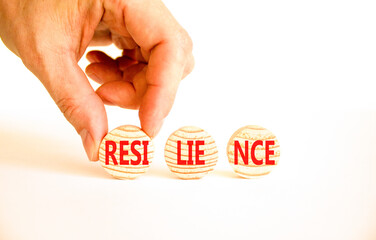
xmin=107 ymin=0 xmax=192 ymax=137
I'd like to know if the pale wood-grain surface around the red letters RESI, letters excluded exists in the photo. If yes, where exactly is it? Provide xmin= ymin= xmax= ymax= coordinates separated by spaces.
xmin=99 ymin=125 xmax=154 ymax=179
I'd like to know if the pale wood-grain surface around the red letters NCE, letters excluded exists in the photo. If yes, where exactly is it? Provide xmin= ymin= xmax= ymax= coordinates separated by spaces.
xmin=227 ymin=125 xmax=280 ymax=178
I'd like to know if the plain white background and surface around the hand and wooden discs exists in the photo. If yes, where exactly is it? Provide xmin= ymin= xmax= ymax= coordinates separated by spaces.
xmin=0 ymin=0 xmax=376 ymax=240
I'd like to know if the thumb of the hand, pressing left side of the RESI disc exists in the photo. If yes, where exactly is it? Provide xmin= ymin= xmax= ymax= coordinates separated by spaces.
xmin=32 ymin=54 xmax=108 ymax=161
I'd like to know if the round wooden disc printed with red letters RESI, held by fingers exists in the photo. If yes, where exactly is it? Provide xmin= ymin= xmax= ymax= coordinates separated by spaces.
xmin=99 ymin=125 xmax=154 ymax=179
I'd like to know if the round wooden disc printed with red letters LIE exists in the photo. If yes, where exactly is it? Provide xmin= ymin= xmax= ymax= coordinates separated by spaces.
xmin=165 ymin=126 xmax=218 ymax=179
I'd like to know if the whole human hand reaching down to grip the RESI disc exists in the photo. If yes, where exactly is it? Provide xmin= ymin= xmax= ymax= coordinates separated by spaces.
xmin=0 ymin=0 xmax=194 ymax=161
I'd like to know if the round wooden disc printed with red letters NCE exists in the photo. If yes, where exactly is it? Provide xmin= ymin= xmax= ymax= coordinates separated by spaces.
xmin=227 ymin=125 xmax=280 ymax=178
